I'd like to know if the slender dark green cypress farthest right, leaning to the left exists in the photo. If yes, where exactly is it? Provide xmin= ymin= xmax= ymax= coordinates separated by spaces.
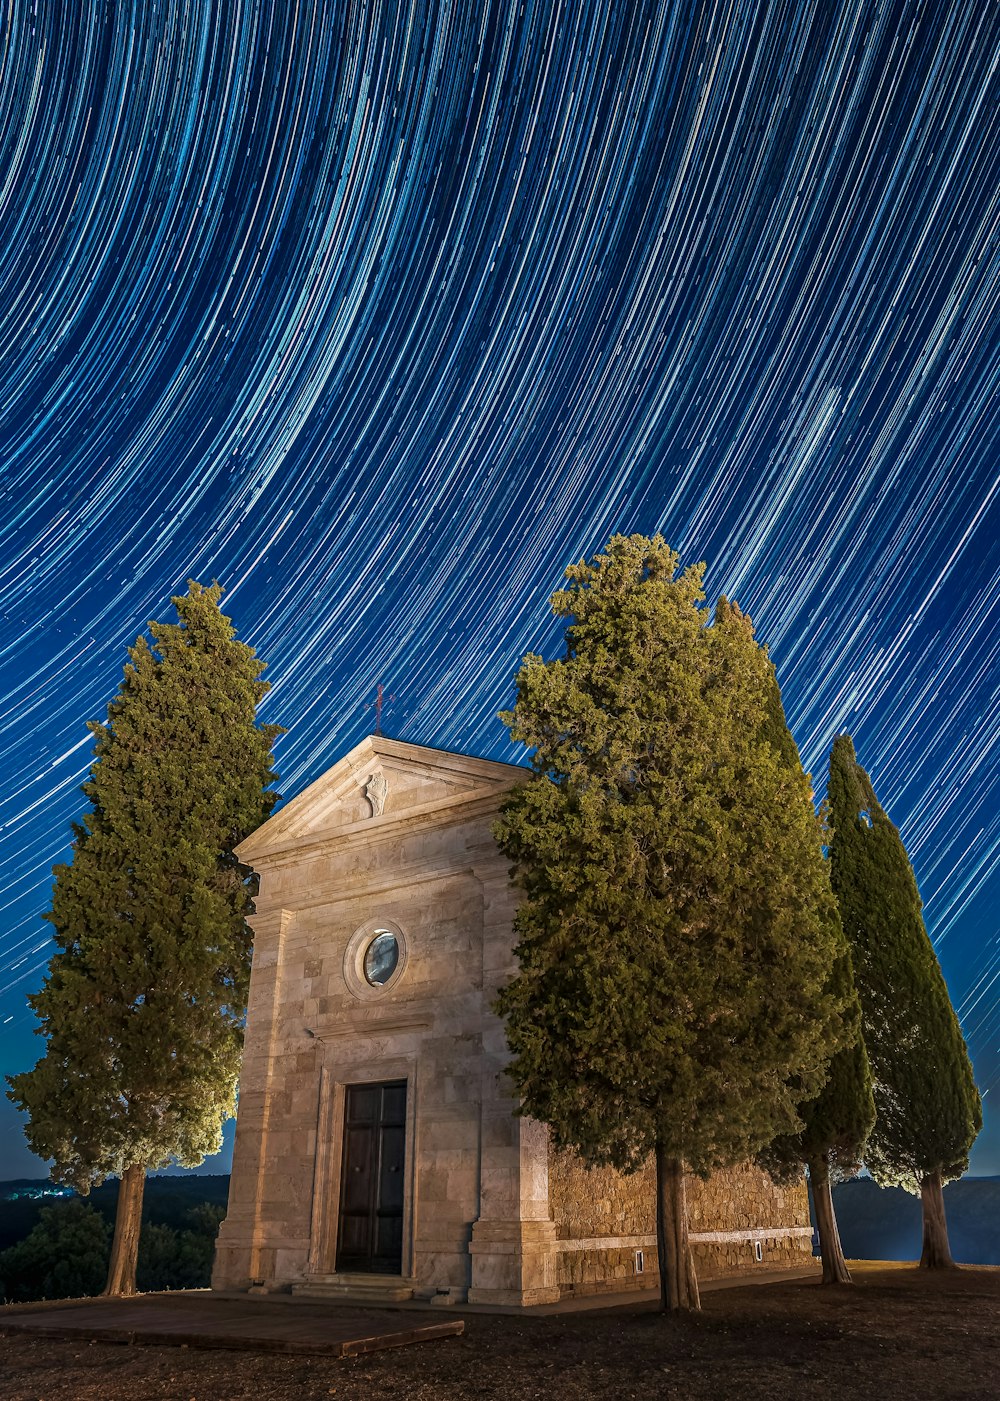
xmin=828 ymin=734 xmax=983 ymax=1268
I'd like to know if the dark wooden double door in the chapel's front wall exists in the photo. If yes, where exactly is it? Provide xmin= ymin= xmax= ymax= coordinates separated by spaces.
xmin=336 ymin=1080 xmax=406 ymax=1275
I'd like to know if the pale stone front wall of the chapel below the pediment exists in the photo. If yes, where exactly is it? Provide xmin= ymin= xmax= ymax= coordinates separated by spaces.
xmin=213 ymin=750 xmax=514 ymax=1293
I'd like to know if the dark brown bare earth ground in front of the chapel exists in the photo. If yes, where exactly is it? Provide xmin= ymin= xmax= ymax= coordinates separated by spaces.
xmin=0 ymin=1264 xmax=1000 ymax=1401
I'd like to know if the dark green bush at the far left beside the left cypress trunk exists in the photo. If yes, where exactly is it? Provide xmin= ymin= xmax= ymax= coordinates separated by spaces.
xmin=0 ymin=1199 xmax=111 ymax=1303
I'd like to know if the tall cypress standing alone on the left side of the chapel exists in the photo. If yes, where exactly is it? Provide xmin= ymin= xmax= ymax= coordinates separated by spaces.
xmin=10 ymin=581 xmax=282 ymax=1293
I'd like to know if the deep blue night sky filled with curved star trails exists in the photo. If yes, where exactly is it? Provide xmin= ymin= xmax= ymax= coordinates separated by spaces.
xmin=0 ymin=0 xmax=1000 ymax=1177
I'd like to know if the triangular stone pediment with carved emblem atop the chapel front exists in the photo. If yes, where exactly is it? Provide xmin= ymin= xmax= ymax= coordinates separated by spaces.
xmin=237 ymin=736 xmax=527 ymax=864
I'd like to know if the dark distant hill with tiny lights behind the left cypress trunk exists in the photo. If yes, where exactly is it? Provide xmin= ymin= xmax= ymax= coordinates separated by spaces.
xmin=0 ymin=1174 xmax=230 ymax=1250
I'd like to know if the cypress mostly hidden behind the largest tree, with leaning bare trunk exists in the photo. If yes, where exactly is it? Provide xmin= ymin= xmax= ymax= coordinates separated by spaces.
xmin=716 ymin=598 xmax=875 ymax=1285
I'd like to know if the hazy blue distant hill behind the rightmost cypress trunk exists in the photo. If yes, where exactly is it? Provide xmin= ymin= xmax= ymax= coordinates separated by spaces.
xmin=833 ymin=1177 xmax=1000 ymax=1265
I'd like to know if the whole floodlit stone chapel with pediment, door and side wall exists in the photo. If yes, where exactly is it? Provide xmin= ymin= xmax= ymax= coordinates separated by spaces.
xmin=213 ymin=737 xmax=811 ymax=1306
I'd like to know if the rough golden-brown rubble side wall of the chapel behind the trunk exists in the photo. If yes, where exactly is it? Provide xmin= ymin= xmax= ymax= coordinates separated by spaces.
xmin=549 ymin=1149 xmax=811 ymax=1296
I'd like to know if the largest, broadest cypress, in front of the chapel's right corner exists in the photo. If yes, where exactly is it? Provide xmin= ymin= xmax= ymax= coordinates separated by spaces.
xmin=496 ymin=535 xmax=839 ymax=1310
